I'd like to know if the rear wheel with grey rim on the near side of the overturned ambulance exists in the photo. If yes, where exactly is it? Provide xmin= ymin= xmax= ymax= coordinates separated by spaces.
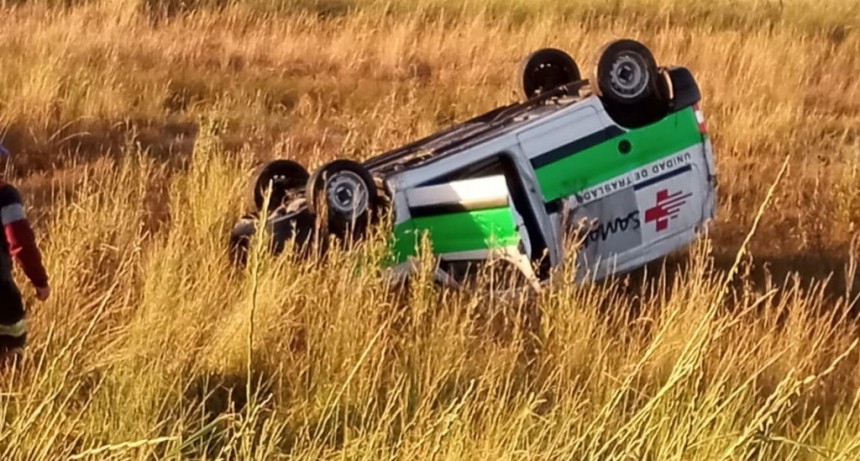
xmin=593 ymin=39 xmax=665 ymax=105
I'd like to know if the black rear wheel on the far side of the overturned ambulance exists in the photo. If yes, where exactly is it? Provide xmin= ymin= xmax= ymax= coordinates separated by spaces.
xmin=520 ymin=48 xmax=582 ymax=99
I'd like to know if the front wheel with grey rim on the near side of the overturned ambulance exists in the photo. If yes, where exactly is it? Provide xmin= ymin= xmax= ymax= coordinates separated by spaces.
xmin=305 ymin=159 xmax=379 ymax=237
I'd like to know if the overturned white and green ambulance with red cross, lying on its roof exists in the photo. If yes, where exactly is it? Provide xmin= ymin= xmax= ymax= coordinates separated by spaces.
xmin=225 ymin=39 xmax=716 ymax=284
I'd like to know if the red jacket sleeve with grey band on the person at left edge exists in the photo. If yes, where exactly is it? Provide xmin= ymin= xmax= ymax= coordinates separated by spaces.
xmin=0 ymin=183 xmax=48 ymax=287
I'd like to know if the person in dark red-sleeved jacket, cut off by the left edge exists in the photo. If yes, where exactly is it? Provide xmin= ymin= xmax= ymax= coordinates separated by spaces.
xmin=0 ymin=145 xmax=51 ymax=355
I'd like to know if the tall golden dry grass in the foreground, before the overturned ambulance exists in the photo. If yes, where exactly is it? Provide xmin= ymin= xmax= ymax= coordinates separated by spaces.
xmin=0 ymin=124 xmax=860 ymax=460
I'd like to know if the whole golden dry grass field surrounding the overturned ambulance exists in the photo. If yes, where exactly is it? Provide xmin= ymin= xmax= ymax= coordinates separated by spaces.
xmin=0 ymin=0 xmax=860 ymax=461
